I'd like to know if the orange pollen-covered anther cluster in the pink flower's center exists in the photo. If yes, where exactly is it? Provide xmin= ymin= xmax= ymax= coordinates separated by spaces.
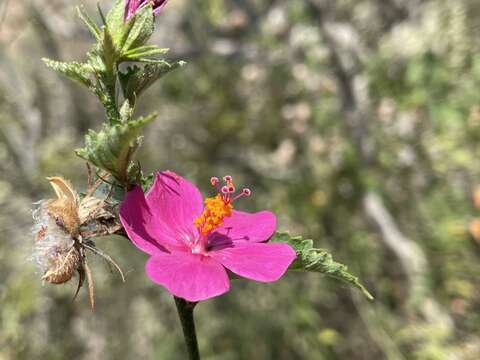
xmin=194 ymin=194 xmax=233 ymax=236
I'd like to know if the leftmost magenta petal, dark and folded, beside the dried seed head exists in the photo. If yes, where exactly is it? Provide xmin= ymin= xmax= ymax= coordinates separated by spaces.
xmin=120 ymin=186 xmax=184 ymax=255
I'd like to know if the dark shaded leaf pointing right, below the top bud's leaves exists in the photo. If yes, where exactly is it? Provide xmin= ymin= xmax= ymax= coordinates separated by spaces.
xmin=119 ymin=60 xmax=185 ymax=104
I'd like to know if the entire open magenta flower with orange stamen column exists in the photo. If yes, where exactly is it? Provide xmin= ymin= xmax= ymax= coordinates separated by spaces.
xmin=120 ymin=171 xmax=296 ymax=301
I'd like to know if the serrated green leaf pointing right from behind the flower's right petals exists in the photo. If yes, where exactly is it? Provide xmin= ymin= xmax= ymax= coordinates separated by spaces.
xmin=270 ymin=232 xmax=373 ymax=300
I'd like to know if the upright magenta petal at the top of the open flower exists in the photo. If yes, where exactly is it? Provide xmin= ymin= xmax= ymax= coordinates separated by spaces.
xmin=146 ymin=170 xmax=203 ymax=238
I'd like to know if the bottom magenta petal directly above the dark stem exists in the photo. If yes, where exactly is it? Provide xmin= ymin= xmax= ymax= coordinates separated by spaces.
xmin=145 ymin=252 xmax=230 ymax=301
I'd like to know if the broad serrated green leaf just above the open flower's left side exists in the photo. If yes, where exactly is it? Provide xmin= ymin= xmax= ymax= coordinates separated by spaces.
xmin=76 ymin=114 xmax=156 ymax=183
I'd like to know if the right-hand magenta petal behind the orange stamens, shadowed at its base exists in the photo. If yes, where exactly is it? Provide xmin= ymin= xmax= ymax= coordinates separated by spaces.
xmin=209 ymin=210 xmax=277 ymax=250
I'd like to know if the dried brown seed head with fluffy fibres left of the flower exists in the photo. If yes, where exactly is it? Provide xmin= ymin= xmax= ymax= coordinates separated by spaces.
xmin=33 ymin=176 xmax=124 ymax=308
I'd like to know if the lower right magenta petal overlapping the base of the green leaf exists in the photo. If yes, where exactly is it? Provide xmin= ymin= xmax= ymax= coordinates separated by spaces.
xmin=209 ymin=242 xmax=296 ymax=282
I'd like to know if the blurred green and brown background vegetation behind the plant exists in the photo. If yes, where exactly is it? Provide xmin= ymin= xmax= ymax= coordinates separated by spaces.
xmin=0 ymin=0 xmax=480 ymax=360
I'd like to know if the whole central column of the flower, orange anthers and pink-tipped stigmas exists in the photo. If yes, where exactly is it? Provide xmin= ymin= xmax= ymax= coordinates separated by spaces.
xmin=194 ymin=175 xmax=252 ymax=248
